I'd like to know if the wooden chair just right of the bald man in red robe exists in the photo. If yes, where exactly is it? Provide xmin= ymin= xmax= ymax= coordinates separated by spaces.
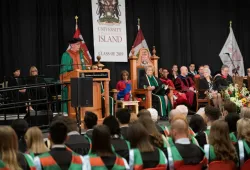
xmin=194 ymin=77 xmax=210 ymax=111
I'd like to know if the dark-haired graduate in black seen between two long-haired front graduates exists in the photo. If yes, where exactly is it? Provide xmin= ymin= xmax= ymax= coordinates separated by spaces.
xmin=103 ymin=116 xmax=130 ymax=161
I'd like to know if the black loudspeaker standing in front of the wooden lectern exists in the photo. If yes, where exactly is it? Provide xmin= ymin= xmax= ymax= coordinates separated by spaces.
xmin=71 ymin=77 xmax=93 ymax=107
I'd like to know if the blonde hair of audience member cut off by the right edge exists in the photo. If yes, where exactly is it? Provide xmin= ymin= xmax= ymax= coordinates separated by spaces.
xmin=237 ymin=118 xmax=250 ymax=142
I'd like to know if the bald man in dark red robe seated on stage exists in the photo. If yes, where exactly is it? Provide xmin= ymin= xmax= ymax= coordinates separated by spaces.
xmin=175 ymin=66 xmax=195 ymax=107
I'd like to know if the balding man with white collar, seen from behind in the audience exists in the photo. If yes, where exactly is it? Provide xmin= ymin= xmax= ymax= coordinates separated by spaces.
xmin=168 ymin=118 xmax=206 ymax=169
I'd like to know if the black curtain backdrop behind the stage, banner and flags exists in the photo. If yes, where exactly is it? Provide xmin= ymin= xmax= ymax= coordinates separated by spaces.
xmin=0 ymin=0 xmax=250 ymax=88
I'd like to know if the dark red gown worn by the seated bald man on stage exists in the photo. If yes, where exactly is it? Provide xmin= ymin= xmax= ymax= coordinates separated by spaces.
xmin=175 ymin=75 xmax=195 ymax=107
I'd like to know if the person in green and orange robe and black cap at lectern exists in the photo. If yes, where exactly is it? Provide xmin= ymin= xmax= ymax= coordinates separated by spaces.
xmin=60 ymin=38 xmax=86 ymax=113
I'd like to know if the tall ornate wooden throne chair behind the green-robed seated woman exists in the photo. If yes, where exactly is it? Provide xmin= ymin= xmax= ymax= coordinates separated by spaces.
xmin=129 ymin=47 xmax=159 ymax=109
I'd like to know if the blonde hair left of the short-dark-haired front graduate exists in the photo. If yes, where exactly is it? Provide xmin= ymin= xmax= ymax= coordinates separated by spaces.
xmin=25 ymin=127 xmax=49 ymax=154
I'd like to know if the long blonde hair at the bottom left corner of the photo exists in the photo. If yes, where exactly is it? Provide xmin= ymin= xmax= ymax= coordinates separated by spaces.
xmin=0 ymin=126 xmax=22 ymax=170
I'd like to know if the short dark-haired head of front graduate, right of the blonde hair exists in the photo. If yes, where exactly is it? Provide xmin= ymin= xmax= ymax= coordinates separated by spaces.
xmin=49 ymin=120 xmax=68 ymax=144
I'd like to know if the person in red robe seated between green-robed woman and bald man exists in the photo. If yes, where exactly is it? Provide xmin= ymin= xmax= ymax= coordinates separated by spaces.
xmin=160 ymin=68 xmax=187 ymax=106
